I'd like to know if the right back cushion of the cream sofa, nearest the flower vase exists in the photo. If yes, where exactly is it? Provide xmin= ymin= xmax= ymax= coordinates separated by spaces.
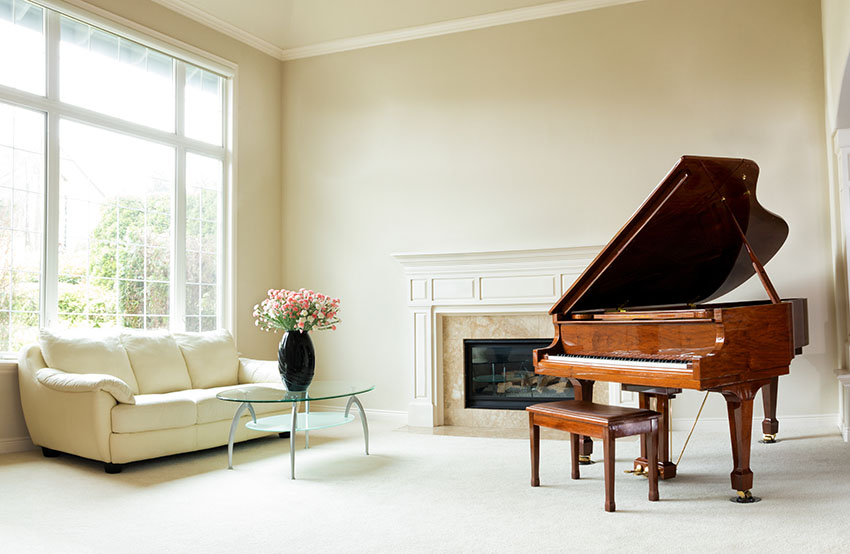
xmin=174 ymin=329 xmax=239 ymax=389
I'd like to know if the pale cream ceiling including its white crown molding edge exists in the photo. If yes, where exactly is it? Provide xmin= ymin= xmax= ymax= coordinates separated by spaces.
xmin=154 ymin=0 xmax=638 ymax=60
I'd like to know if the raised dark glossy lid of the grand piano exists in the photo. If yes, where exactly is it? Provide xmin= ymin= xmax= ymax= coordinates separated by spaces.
xmin=549 ymin=156 xmax=788 ymax=314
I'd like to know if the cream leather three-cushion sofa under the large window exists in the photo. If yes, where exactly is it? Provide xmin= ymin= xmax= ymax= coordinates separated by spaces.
xmin=18 ymin=330 xmax=288 ymax=473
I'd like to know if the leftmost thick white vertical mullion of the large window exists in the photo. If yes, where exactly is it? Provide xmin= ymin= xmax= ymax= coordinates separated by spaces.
xmin=41 ymin=10 xmax=60 ymax=327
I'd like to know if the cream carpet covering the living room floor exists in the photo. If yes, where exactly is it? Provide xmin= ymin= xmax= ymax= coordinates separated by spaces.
xmin=0 ymin=416 xmax=850 ymax=554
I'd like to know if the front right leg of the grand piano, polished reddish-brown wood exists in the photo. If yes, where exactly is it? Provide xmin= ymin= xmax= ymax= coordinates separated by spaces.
xmin=720 ymin=379 xmax=770 ymax=503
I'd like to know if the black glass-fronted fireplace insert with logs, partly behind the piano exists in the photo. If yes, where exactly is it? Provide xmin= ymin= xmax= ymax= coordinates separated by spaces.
xmin=463 ymin=339 xmax=574 ymax=410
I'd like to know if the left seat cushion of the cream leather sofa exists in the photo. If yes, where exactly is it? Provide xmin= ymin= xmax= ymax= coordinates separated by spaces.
xmin=112 ymin=391 xmax=197 ymax=433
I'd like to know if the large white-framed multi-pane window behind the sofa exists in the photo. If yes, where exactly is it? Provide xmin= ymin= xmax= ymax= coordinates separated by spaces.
xmin=0 ymin=0 xmax=230 ymax=353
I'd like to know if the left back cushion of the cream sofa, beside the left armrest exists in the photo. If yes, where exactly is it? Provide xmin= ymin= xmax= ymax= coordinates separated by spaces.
xmin=38 ymin=329 xmax=139 ymax=394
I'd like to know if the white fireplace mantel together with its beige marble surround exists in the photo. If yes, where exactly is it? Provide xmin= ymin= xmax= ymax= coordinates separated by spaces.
xmin=392 ymin=246 xmax=630 ymax=427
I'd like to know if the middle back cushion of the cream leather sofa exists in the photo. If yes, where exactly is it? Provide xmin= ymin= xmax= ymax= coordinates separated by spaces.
xmin=121 ymin=331 xmax=192 ymax=394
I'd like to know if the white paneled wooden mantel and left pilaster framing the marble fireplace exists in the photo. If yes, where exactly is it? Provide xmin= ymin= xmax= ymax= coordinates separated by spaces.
xmin=392 ymin=246 xmax=602 ymax=427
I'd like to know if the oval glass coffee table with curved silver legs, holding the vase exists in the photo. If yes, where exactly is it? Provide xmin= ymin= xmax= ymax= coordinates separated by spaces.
xmin=215 ymin=381 xmax=375 ymax=479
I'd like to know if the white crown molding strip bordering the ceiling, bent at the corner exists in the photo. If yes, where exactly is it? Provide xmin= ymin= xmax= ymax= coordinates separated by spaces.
xmin=153 ymin=0 xmax=642 ymax=61
